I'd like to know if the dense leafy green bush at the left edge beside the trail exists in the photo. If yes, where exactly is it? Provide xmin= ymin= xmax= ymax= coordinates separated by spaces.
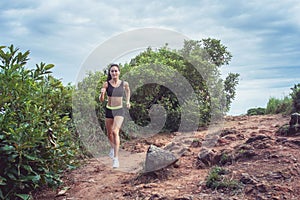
xmin=0 ymin=45 xmax=78 ymax=199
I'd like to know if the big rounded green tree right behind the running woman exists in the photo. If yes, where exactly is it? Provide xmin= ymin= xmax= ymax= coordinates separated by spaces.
xmin=125 ymin=38 xmax=239 ymax=131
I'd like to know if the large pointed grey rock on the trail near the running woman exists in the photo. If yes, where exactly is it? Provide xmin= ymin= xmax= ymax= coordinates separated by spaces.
xmin=145 ymin=145 xmax=178 ymax=172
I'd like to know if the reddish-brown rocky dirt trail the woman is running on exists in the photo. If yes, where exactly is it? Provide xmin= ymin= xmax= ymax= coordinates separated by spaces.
xmin=33 ymin=115 xmax=300 ymax=200
